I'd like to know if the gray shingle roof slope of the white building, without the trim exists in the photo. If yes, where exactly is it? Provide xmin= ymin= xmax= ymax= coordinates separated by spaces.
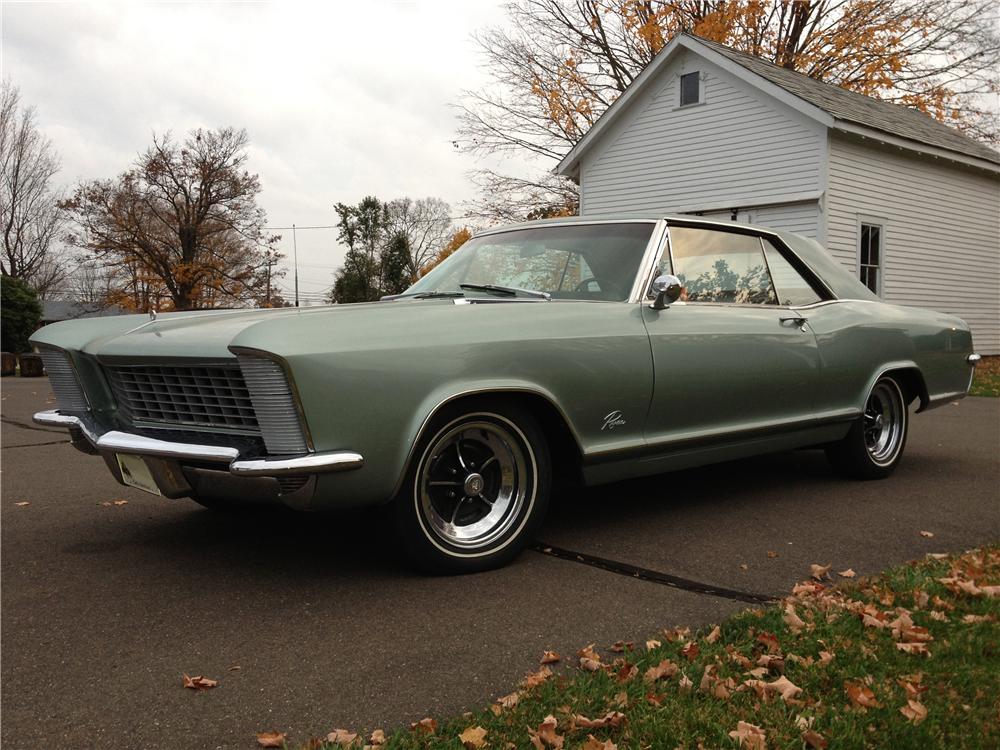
xmin=689 ymin=35 xmax=1000 ymax=164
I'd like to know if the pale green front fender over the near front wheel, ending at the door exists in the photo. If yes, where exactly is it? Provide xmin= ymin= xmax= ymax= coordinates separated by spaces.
xmin=233 ymin=301 xmax=653 ymax=506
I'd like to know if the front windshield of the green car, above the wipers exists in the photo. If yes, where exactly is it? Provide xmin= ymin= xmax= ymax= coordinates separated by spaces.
xmin=406 ymin=222 xmax=654 ymax=302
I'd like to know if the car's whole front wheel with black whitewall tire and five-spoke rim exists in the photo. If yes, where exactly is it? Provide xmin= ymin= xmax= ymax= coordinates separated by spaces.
xmin=393 ymin=402 xmax=551 ymax=573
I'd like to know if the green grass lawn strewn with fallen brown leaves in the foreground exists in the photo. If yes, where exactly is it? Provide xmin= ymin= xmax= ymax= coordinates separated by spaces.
xmin=288 ymin=546 xmax=1000 ymax=750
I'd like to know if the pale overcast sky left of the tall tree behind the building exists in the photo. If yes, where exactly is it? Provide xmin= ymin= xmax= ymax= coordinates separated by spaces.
xmin=0 ymin=0 xmax=532 ymax=306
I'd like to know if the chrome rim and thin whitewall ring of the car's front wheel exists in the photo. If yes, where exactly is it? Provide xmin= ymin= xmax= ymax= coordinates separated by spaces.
xmin=413 ymin=412 xmax=537 ymax=557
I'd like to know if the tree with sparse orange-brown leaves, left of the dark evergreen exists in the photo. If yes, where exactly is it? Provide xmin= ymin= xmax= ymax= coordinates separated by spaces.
xmin=62 ymin=128 xmax=281 ymax=310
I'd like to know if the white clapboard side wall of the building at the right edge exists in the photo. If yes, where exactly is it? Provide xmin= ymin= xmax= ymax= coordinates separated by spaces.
xmin=826 ymin=134 xmax=1000 ymax=354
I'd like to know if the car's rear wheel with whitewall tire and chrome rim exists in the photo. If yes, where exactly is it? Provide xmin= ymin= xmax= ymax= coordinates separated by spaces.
xmin=826 ymin=375 xmax=909 ymax=479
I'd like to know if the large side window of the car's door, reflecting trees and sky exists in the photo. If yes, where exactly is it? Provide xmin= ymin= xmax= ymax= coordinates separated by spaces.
xmin=670 ymin=227 xmax=778 ymax=305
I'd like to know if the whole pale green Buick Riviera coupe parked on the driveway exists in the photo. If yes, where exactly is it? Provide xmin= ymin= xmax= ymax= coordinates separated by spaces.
xmin=32 ymin=216 xmax=979 ymax=572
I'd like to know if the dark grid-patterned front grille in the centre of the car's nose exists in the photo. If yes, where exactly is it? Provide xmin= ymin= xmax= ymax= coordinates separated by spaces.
xmin=106 ymin=364 xmax=260 ymax=435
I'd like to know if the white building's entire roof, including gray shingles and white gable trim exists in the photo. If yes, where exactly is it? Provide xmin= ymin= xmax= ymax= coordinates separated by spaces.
xmin=555 ymin=33 xmax=1000 ymax=175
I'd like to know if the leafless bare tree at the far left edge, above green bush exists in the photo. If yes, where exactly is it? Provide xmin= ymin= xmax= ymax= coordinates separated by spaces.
xmin=0 ymin=81 xmax=63 ymax=296
